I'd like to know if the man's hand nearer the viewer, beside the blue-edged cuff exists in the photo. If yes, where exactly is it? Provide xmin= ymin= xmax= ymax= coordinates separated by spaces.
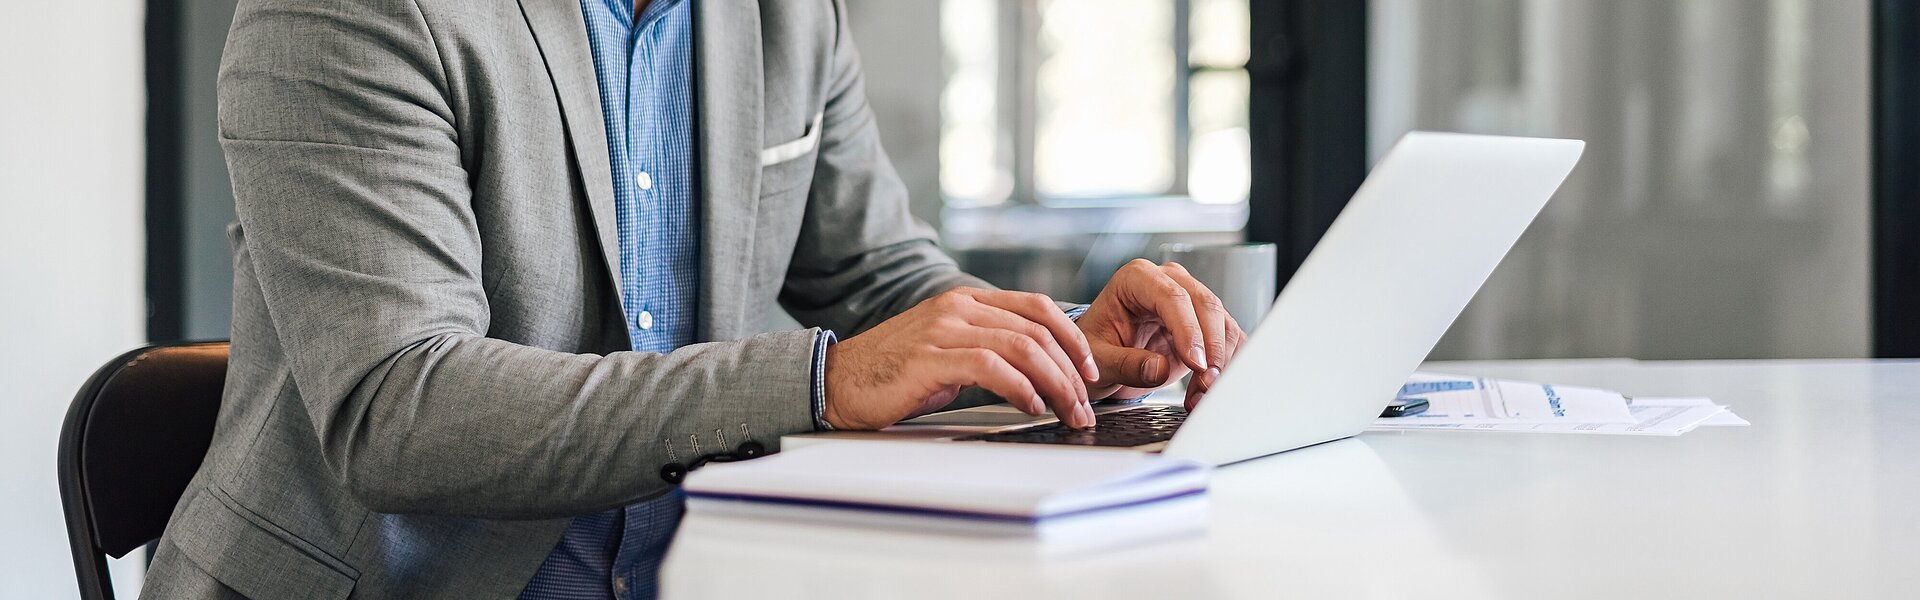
xmin=824 ymin=288 xmax=1100 ymax=429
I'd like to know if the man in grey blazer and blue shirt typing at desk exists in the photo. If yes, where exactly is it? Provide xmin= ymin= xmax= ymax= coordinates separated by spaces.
xmin=148 ymin=0 xmax=1242 ymax=598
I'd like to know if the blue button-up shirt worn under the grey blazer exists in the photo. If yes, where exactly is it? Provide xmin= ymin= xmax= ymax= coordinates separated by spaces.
xmin=520 ymin=0 xmax=701 ymax=600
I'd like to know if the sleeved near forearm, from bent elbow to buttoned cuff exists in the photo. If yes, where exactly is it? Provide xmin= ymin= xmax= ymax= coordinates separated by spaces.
xmin=316 ymin=331 xmax=814 ymax=519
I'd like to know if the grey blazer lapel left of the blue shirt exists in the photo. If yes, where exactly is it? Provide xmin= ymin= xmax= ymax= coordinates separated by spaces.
xmin=520 ymin=0 xmax=626 ymax=309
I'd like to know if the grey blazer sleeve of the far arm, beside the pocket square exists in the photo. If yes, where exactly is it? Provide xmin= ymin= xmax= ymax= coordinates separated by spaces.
xmin=780 ymin=0 xmax=991 ymax=337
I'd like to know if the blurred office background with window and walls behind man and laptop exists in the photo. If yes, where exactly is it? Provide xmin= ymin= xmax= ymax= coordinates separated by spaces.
xmin=0 ymin=0 xmax=1920 ymax=598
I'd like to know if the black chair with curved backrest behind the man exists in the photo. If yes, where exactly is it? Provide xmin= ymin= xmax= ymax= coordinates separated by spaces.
xmin=60 ymin=342 xmax=227 ymax=600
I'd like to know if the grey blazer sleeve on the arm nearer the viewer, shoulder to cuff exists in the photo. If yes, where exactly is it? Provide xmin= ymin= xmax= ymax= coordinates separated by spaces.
xmin=219 ymin=0 xmax=817 ymax=519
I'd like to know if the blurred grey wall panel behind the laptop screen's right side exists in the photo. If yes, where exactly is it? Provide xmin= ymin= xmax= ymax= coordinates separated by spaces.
xmin=1371 ymin=0 xmax=1868 ymax=358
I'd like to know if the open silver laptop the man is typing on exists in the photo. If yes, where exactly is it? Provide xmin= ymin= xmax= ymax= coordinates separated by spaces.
xmin=783 ymin=133 xmax=1586 ymax=465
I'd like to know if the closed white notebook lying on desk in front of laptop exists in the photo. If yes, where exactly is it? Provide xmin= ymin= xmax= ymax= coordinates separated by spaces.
xmin=685 ymin=442 xmax=1208 ymax=531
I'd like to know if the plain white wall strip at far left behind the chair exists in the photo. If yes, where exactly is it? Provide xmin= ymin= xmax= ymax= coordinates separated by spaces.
xmin=0 ymin=0 xmax=146 ymax=598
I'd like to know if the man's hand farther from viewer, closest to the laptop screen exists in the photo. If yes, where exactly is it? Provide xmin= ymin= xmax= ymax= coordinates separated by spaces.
xmin=1079 ymin=260 xmax=1246 ymax=410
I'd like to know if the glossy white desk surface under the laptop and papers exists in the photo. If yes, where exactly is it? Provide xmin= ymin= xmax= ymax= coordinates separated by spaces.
xmin=662 ymin=360 xmax=1920 ymax=598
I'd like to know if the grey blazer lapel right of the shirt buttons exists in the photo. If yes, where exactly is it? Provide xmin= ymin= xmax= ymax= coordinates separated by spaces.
xmin=693 ymin=0 xmax=764 ymax=340
